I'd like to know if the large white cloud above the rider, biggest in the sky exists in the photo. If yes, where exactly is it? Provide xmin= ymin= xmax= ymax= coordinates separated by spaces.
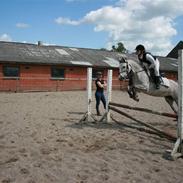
xmin=56 ymin=0 xmax=183 ymax=55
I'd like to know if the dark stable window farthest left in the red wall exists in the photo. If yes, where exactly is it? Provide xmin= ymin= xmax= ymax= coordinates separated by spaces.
xmin=3 ymin=66 xmax=20 ymax=78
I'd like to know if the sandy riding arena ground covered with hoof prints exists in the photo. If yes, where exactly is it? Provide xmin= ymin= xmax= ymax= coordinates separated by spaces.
xmin=0 ymin=91 xmax=183 ymax=183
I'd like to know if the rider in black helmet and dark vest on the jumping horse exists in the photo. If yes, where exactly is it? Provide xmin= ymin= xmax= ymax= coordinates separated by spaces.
xmin=135 ymin=44 xmax=161 ymax=89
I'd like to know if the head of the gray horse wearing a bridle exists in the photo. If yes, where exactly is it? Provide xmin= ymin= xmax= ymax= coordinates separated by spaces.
xmin=119 ymin=57 xmax=129 ymax=80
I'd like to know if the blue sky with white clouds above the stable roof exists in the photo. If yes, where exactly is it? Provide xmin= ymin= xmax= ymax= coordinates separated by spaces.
xmin=0 ymin=0 xmax=183 ymax=56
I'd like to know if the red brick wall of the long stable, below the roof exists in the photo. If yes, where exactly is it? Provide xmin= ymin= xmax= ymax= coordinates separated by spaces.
xmin=0 ymin=64 xmax=127 ymax=92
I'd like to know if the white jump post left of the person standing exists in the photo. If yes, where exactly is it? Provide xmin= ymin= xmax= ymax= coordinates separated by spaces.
xmin=79 ymin=67 xmax=97 ymax=122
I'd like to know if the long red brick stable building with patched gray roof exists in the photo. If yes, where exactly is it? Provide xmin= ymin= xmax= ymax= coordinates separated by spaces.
xmin=0 ymin=42 xmax=177 ymax=91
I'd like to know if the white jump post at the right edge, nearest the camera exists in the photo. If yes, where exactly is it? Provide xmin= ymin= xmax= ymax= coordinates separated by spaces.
xmin=171 ymin=50 xmax=183 ymax=159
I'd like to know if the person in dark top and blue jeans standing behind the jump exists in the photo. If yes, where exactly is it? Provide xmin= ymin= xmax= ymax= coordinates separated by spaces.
xmin=95 ymin=72 xmax=106 ymax=116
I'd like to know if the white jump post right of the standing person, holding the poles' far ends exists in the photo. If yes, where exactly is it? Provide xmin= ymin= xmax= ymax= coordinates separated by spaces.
xmin=99 ymin=69 xmax=113 ymax=122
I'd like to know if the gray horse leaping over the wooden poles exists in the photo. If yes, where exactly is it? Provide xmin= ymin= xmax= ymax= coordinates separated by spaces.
xmin=119 ymin=57 xmax=178 ymax=114
